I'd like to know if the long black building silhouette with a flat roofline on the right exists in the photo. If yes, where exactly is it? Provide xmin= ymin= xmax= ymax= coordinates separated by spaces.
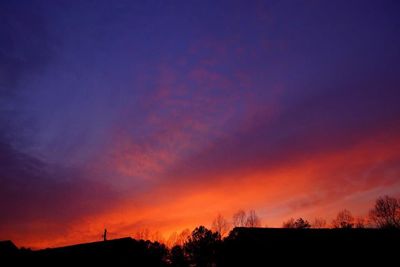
xmin=221 ymin=227 xmax=400 ymax=266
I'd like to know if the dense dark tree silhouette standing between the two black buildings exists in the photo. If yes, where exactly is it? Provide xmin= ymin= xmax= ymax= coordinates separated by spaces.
xmin=184 ymin=226 xmax=221 ymax=266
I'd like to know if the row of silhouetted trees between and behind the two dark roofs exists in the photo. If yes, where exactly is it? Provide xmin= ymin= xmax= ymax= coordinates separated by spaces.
xmin=126 ymin=196 xmax=400 ymax=266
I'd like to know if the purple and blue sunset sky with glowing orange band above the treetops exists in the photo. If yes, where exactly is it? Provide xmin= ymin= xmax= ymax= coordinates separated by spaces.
xmin=0 ymin=0 xmax=400 ymax=248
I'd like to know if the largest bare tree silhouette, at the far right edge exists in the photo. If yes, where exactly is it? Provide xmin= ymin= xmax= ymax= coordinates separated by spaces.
xmin=369 ymin=196 xmax=400 ymax=228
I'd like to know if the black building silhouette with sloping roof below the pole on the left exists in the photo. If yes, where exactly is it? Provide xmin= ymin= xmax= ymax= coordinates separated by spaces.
xmin=10 ymin=237 xmax=165 ymax=266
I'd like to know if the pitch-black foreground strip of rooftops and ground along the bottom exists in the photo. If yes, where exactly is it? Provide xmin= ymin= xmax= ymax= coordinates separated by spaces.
xmin=0 ymin=228 xmax=400 ymax=266
